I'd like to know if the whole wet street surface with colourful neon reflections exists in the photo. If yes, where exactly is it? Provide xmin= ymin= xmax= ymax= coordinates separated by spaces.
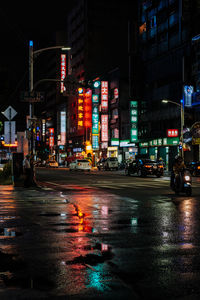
xmin=0 ymin=168 xmax=200 ymax=299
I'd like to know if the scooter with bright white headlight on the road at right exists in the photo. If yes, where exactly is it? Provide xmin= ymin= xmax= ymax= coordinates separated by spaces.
xmin=171 ymin=169 xmax=192 ymax=196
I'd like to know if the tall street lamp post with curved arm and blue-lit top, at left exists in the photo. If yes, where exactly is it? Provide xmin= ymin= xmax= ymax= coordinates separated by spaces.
xmin=29 ymin=41 xmax=71 ymax=154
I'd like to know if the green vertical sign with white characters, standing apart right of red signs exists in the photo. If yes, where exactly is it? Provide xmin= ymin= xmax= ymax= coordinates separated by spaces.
xmin=130 ymin=101 xmax=138 ymax=142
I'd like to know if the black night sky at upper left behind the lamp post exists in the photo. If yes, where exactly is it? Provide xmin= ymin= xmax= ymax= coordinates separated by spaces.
xmin=0 ymin=0 xmax=75 ymax=125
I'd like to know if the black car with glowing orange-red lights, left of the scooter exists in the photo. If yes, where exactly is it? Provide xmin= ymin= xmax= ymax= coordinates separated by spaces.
xmin=125 ymin=159 xmax=164 ymax=177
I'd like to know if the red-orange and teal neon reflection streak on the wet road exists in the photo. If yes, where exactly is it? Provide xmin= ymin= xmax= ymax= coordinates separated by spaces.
xmin=61 ymin=192 xmax=115 ymax=292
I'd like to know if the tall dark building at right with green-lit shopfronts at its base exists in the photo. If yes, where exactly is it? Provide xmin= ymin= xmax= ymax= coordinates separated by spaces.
xmin=138 ymin=0 xmax=199 ymax=167
